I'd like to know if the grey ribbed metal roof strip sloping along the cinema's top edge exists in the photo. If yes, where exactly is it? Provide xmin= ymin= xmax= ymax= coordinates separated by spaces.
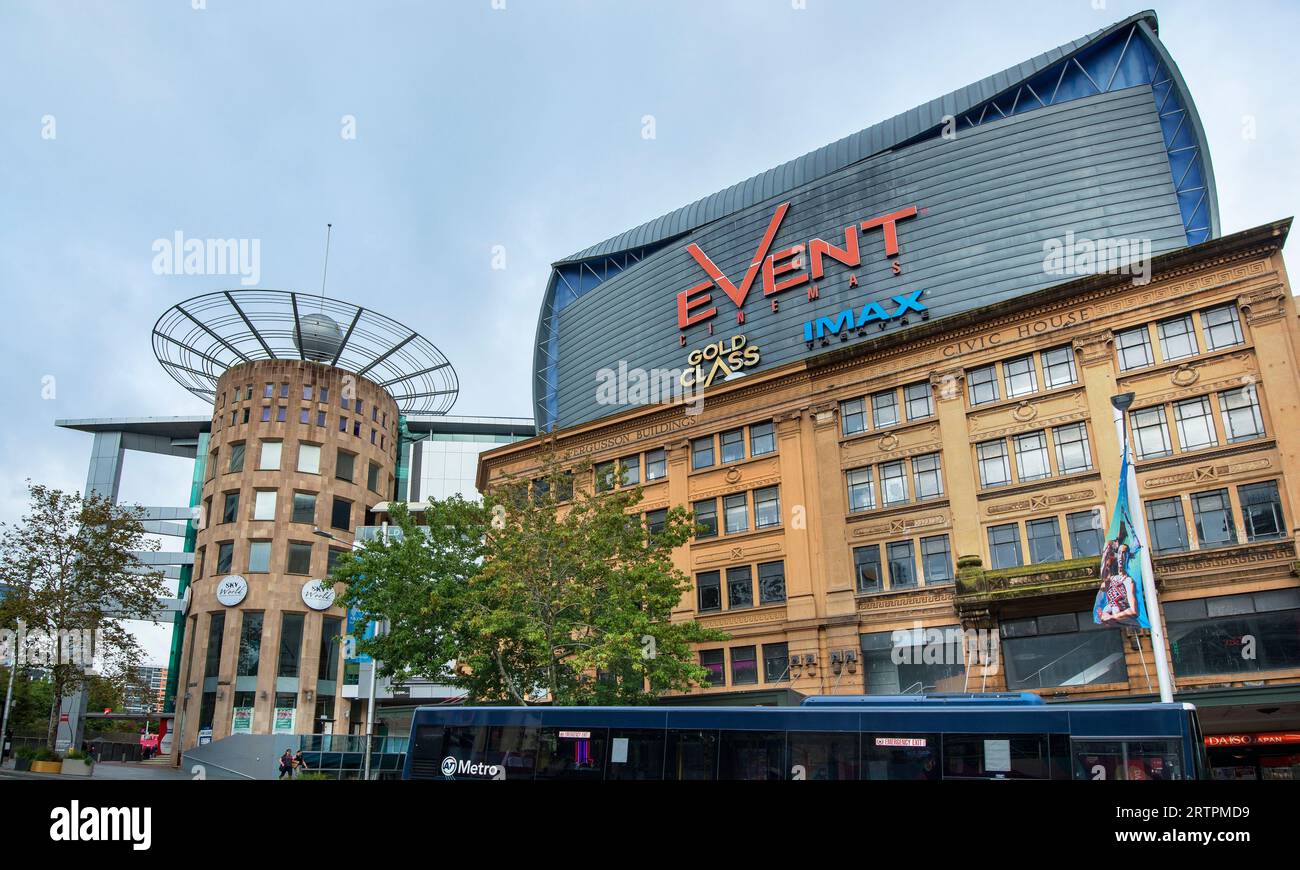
xmin=553 ymin=9 xmax=1164 ymax=265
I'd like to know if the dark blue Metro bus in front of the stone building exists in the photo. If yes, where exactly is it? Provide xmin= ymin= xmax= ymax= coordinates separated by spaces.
xmin=402 ymin=693 xmax=1206 ymax=780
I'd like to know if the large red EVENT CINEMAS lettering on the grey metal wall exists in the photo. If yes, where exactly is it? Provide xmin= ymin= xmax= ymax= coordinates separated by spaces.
xmin=677 ymin=203 xmax=917 ymax=329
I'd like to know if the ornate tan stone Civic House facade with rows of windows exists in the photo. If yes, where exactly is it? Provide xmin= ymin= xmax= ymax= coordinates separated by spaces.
xmin=478 ymin=221 xmax=1300 ymax=731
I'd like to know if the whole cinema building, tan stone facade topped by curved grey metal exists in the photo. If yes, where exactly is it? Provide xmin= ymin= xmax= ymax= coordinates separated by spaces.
xmin=478 ymin=13 xmax=1300 ymax=776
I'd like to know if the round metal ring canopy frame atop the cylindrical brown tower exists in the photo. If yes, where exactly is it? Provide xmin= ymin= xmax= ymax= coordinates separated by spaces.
xmin=153 ymin=290 xmax=460 ymax=415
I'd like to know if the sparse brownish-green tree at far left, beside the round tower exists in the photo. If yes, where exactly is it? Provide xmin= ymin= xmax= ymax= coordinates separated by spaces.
xmin=0 ymin=482 xmax=166 ymax=749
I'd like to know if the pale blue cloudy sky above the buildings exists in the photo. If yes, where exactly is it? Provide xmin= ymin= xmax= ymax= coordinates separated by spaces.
xmin=0 ymin=0 xmax=1300 ymax=663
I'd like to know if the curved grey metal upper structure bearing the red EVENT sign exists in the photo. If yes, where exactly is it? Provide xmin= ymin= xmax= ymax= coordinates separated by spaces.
xmin=533 ymin=12 xmax=1219 ymax=430
